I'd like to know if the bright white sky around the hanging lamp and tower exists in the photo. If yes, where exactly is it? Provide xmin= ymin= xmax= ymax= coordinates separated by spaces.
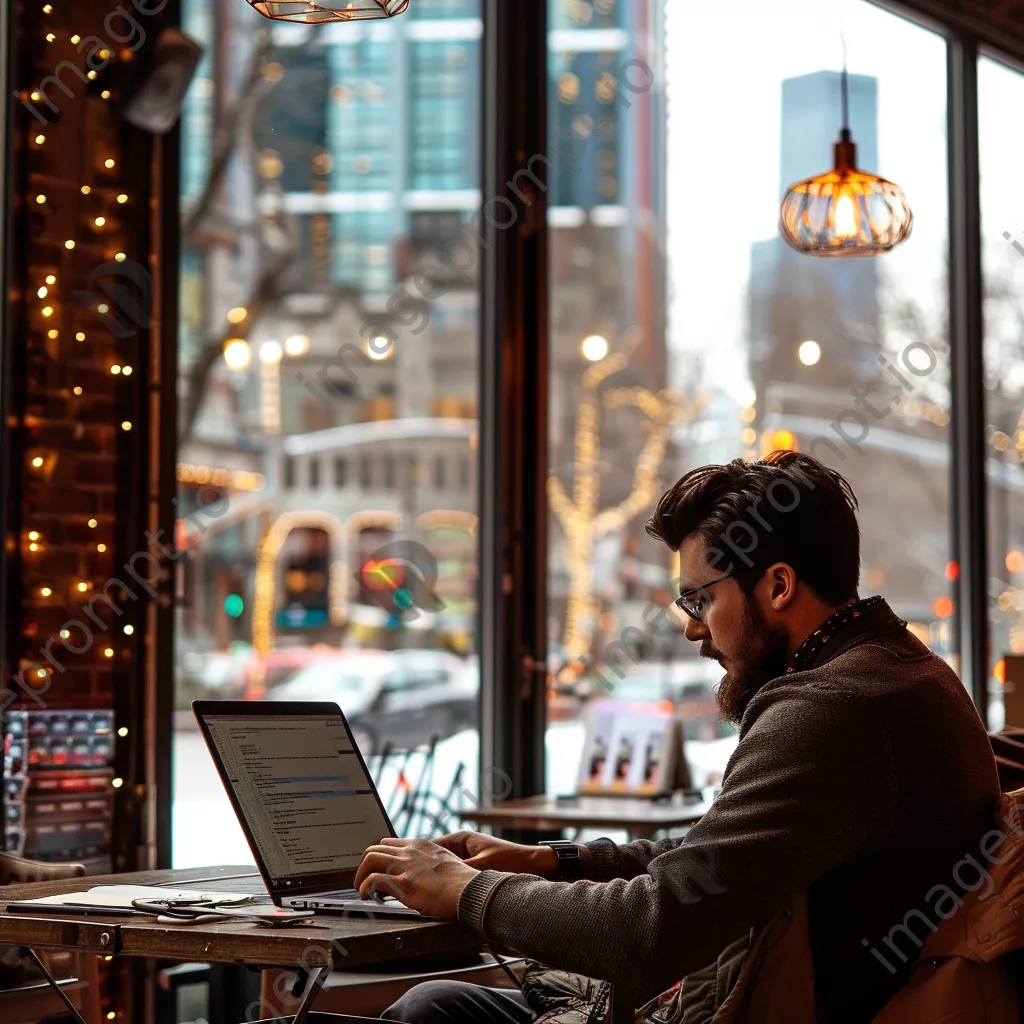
xmin=666 ymin=0 xmax=1024 ymax=401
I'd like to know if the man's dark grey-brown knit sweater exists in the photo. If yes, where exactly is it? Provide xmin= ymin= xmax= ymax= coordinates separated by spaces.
xmin=459 ymin=600 xmax=998 ymax=1024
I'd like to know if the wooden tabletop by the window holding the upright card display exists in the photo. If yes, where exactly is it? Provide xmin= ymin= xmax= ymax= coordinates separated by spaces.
xmin=456 ymin=796 xmax=711 ymax=839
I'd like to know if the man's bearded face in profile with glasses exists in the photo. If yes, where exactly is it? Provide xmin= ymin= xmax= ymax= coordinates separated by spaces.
xmin=679 ymin=537 xmax=788 ymax=723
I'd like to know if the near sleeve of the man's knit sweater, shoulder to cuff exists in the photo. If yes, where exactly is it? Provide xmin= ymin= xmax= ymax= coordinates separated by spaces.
xmin=459 ymin=684 xmax=891 ymax=997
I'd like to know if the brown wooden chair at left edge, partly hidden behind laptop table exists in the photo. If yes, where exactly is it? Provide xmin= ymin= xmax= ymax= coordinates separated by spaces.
xmin=0 ymin=853 xmax=99 ymax=1024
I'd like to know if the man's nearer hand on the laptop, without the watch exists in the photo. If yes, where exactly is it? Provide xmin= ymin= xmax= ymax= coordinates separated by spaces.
xmin=355 ymin=838 xmax=479 ymax=920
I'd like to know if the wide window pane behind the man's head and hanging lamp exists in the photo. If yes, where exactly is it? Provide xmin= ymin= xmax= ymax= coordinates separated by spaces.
xmin=548 ymin=0 xmax=956 ymax=793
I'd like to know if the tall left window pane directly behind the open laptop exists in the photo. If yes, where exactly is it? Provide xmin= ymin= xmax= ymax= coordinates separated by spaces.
xmin=173 ymin=0 xmax=482 ymax=866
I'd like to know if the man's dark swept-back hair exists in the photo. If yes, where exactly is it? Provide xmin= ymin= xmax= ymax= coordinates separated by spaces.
xmin=647 ymin=452 xmax=860 ymax=604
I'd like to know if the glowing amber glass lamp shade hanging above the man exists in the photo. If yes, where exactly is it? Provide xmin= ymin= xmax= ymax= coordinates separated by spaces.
xmin=779 ymin=129 xmax=913 ymax=256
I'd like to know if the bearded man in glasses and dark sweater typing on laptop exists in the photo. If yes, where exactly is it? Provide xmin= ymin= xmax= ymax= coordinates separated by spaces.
xmin=356 ymin=452 xmax=998 ymax=1024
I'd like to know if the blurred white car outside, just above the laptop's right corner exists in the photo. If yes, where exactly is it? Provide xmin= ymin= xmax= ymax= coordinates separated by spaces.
xmin=266 ymin=650 xmax=479 ymax=756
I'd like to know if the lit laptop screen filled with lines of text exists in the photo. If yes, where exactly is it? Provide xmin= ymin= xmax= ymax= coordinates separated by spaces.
xmin=204 ymin=715 xmax=390 ymax=879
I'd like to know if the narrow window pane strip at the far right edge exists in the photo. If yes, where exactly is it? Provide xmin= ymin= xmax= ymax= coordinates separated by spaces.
xmin=978 ymin=58 xmax=1024 ymax=729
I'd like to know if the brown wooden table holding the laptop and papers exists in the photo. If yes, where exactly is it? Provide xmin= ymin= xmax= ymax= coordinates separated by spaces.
xmin=0 ymin=866 xmax=480 ymax=1024
